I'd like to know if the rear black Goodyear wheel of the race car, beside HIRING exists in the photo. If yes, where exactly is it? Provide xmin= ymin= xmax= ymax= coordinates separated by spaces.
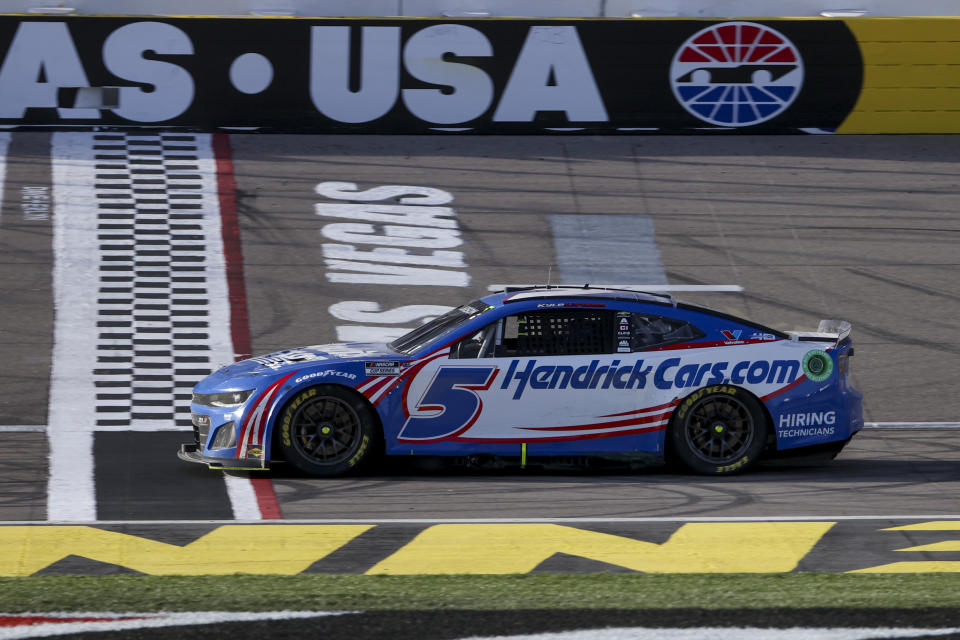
xmin=670 ymin=386 xmax=767 ymax=475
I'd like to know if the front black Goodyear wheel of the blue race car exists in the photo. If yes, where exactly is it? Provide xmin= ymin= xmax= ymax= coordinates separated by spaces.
xmin=277 ymin=385 xmax=379 ymax=477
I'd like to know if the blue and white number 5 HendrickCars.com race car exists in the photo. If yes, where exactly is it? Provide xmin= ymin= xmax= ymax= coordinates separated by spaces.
xmin=179 ymin=285 xmax=863 ymax=476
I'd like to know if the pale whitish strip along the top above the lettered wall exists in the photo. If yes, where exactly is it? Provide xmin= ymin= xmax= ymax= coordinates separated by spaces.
xmin=13 ymin=0 xmax=960 ymax=18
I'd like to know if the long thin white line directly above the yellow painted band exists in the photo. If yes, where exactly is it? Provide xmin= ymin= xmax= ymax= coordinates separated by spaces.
xmin=9 ymin=513 xmax=960 ymax=527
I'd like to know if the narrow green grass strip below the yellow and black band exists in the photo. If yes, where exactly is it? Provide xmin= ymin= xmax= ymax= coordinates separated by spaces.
xmin=0 ymin=573 xmax=960 ymax=613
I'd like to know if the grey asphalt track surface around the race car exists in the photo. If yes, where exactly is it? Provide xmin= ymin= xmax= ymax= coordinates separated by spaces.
xmin=0 ymin=133 xmax=960 ymax=638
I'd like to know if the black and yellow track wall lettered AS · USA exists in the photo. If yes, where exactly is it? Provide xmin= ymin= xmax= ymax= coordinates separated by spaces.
xmin=0 ymin=16 xmax=960 ymax=134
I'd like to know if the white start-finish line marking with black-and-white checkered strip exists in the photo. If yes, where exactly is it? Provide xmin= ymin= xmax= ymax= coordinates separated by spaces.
xmin=47 ymin=133 xmax=256 ymax=521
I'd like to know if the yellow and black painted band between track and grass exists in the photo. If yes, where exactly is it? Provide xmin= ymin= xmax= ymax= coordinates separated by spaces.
xmin=0 ymin=519 xmax=960 ymax=576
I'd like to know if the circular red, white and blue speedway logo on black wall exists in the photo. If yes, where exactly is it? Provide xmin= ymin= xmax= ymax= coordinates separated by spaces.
xmin=670 ymin=22 xmax=803 ymax=127
